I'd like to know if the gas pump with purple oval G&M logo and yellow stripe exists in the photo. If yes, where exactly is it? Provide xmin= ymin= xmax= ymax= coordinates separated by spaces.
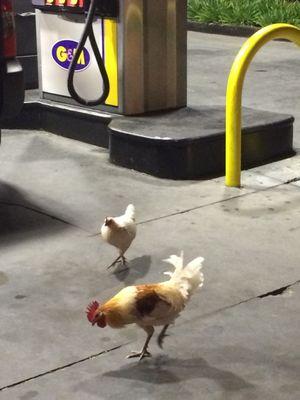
xmin=32 ymin=0 xmax=186 ymax=115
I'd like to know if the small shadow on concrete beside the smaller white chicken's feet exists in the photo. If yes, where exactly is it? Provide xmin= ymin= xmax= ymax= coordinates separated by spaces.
xmin=113 ymin=255 xmax=151 ymax=286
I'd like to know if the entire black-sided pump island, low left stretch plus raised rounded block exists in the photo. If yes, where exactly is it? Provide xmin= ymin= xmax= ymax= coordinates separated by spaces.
xmin=3 ymin=102 xmax=294 ymax=179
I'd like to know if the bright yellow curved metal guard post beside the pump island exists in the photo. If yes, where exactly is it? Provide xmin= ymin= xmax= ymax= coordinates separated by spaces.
xmin=225 ymin=24 xmax=300 ymax=187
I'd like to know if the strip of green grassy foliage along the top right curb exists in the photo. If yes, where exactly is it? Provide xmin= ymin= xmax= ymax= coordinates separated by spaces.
xmin=188 ymin=0 xmax=300 ymax=26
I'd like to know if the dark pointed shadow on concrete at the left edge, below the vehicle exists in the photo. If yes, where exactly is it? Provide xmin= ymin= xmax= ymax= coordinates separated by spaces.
xmin=0 ymin=181 xmax=70 ymax=247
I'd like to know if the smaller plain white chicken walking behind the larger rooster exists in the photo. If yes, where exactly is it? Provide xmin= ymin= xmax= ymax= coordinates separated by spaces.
xmin=101 ymin=204 xmax=136 ymax=269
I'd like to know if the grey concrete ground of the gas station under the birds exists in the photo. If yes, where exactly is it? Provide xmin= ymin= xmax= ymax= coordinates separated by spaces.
xmin=0 ymin=33 xmax=300 ymax=400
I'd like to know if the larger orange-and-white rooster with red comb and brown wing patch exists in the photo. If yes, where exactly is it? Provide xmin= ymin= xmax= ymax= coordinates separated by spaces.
xmin=86 ymin=253 xmax=204 ymax=360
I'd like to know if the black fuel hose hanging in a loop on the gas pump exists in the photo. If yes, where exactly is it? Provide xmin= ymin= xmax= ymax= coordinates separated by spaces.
xmin=68 ymin=0 xmax=109 ymax=106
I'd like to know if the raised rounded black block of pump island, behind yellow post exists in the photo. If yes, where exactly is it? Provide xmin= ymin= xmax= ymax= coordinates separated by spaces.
xmin=109 ymin=107 xmax=294 ymax=179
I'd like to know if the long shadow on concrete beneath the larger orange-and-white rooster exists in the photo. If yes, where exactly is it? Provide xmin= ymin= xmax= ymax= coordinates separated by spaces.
xmin=103 ymin=356 xmax=254 ymax=392
